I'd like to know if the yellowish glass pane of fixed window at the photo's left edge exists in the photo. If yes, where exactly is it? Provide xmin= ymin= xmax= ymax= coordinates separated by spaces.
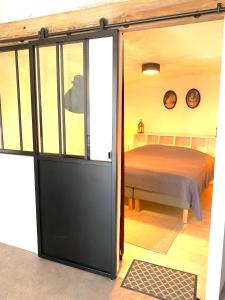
xmin=0 ymin=51 xmax=20 ymax=150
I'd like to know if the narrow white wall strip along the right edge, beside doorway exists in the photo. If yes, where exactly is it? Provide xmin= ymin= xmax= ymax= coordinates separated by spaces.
xmin=206 ymin=18 xmax=225 ymax=300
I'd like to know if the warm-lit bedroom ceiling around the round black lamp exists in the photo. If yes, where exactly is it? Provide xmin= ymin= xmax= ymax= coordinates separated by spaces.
xmin=124 ymin=20 xmax=223 ymax=82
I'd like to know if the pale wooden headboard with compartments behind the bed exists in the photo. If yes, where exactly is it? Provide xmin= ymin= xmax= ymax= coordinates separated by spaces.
xmin=134 ymin=133 xmax=216 ymax=156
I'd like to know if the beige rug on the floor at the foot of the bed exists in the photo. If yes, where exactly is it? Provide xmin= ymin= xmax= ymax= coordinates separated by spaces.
xmin=124 ymin=205 xmax=183 ymax=254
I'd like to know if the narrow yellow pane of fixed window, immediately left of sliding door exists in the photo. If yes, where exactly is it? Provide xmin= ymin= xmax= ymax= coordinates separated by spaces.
xmin=18 ymin=50 xmax=33 ymax=151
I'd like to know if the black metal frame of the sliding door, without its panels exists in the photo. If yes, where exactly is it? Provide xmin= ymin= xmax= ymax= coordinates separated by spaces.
xmin=29 ymin=30 xmax=120 ymax=279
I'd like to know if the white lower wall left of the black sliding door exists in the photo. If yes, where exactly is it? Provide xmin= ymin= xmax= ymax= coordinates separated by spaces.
xmin=0 ymin=154 xmax=37 ymax=252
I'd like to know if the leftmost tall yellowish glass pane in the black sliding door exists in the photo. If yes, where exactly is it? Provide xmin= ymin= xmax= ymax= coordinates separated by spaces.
xmin=39 ymin=46 xmax=59 ymax=153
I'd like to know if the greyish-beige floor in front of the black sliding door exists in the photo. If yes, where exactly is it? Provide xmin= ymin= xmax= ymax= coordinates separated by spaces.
xmin=0 ymin=244 xmax=151 ymax=300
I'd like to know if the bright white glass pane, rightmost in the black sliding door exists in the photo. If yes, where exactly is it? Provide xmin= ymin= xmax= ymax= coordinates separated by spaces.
xmin=89 ymin=37 xmax=113 ymax=161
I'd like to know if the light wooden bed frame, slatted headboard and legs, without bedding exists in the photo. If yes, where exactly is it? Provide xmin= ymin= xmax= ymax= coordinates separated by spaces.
xmin=125 ymin=133 xmax=216 ymax=224
